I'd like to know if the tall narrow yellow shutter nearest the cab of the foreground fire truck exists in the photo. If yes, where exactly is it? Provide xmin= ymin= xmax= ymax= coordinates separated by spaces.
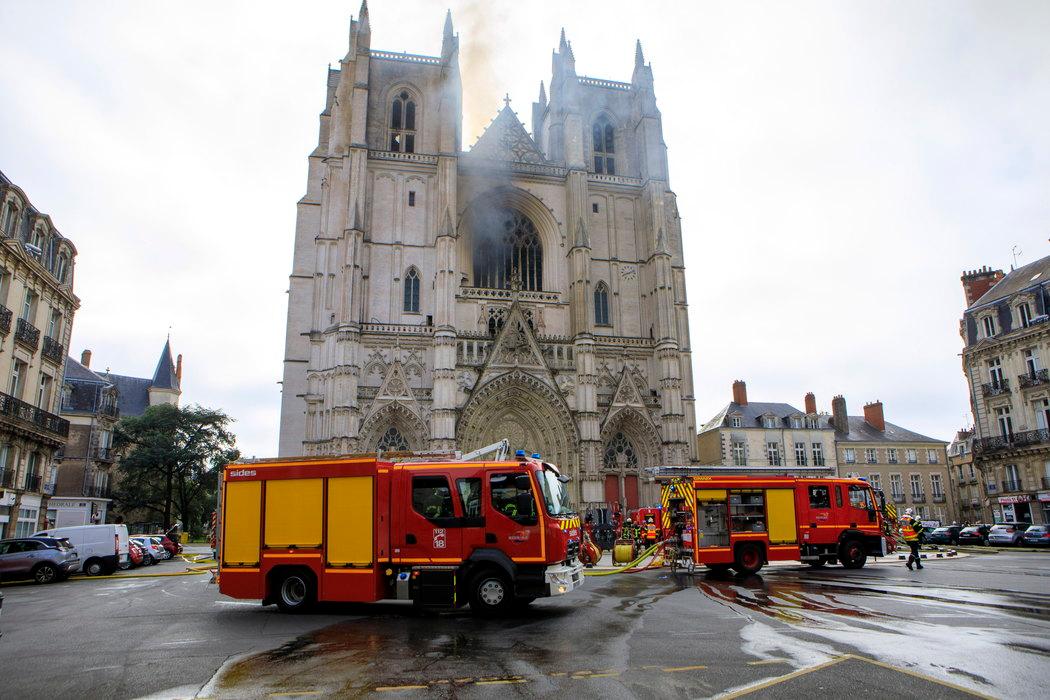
xmin=328 ymin=476 xmax=373 ymax=567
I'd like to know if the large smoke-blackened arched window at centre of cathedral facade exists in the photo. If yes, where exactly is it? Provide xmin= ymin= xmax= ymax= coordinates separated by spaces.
xmin=471 ymin=208 xmax=543 ymax=292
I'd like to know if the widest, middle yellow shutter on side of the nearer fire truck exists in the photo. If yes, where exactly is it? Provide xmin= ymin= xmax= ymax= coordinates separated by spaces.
xmin=264 ymin=479 xmax=323 ymax=548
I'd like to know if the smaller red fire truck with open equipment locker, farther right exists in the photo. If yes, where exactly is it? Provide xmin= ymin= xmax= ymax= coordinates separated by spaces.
xmin=663 ymin=475 xmax=893 ymax=573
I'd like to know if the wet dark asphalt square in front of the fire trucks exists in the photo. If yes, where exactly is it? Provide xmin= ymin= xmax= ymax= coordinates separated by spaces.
xmin=0 ymin=553 xmax=1050 ymax=698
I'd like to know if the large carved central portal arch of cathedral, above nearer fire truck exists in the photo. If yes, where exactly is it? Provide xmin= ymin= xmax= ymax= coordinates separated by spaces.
xmin=456 ymin=370 xmax=579 ymax=484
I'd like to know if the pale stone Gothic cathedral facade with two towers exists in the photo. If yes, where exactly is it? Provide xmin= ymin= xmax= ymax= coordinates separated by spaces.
xmin=279 ymin=5 xmax=696 ymax=506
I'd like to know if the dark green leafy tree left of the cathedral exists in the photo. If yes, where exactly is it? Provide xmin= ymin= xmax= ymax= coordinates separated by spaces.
xmin=113 ymin=404 xmax=239 ymax=532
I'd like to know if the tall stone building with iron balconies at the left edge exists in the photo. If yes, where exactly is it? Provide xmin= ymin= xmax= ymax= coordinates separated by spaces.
xmin=0 ymin=167 xmax=80 ymax=537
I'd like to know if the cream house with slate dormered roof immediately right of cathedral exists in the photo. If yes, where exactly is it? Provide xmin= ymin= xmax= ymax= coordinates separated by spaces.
xmin=697 ymin=380 xmax=838 ymax=476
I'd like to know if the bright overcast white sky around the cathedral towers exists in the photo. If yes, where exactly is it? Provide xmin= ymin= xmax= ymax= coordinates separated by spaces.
xmin=0 ymin=0 xmax=1050 ymax=457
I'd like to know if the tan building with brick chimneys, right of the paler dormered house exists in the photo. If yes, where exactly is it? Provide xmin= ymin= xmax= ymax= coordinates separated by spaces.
xmin=832 ymin=396 xmax=959 ymax=524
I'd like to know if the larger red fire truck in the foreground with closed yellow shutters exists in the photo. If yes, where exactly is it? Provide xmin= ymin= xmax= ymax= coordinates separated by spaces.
xmin=219 ymin=455 xmax=583 ymax=614
